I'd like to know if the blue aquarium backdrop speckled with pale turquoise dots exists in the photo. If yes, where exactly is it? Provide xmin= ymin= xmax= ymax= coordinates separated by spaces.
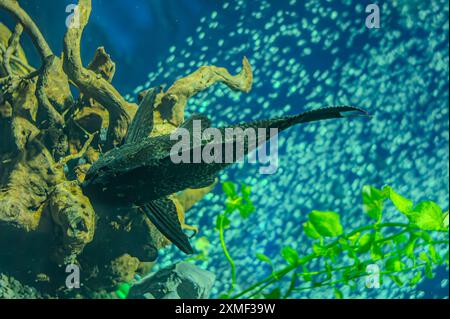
xmin=0 ymin=0 xmax=449 ymax=298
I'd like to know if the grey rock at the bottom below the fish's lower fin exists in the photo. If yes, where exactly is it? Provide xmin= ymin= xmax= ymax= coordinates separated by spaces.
xmin=128 ymin=262 xmax=216 ymax=299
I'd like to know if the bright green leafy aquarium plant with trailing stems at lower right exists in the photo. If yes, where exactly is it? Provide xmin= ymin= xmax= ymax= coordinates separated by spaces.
xmin=217 ymin=181 xmax=449 ymax=299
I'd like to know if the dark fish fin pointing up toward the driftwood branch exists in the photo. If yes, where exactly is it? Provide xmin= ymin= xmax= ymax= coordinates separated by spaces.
xmin=125 ymin=87 xmax=161 ymax=144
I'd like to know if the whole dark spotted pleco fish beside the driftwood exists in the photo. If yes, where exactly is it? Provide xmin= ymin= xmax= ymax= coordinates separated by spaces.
xmin=83 ymin=88 xmax=368 ymax=254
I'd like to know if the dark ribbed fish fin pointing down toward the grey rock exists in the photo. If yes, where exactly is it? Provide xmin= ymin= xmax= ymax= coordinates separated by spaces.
xmin=140 ymin=197 xmax=194 ymax=254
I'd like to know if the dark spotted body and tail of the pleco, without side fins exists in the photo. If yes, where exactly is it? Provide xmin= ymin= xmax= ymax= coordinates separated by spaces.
xmin=83 ymin=106 xmax=368 ymax=205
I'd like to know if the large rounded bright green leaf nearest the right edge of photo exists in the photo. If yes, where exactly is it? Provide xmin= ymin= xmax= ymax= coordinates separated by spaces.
xmin=407 ymin=201 xmax=443 ymax=230
